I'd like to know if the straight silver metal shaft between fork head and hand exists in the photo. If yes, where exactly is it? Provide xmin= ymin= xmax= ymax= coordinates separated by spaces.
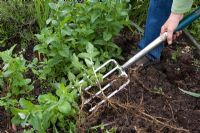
xmin=122 ymin=32 xmax=167 ymax=69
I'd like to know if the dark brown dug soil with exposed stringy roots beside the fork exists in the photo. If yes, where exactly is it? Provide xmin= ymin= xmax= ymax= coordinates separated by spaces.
xmin=78 ymin=31 xmax=200 ymax=133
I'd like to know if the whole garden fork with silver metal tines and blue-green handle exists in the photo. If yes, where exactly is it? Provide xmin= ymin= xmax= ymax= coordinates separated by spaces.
xmin=80 ymin=7 xmax=200 ymax=112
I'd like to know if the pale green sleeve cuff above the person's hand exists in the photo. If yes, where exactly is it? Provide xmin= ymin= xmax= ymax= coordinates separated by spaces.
xmin=172 ymin=0 xmax=193 ymax=14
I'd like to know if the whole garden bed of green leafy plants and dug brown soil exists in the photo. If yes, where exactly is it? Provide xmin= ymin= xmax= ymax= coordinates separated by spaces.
xmin=0 ymin=0 xmax=200 ymax=133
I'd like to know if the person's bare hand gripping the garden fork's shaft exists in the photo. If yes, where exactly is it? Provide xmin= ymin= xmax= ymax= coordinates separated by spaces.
xmin=161 ymin=13 xmax=183 ymax=44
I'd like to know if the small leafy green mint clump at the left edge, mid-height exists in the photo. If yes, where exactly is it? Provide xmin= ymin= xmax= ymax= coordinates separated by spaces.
xmin=0 ymin=46 xmax=33 ymax=96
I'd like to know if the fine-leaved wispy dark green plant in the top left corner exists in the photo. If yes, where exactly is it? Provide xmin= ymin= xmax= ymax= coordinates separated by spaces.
xmin=0 ymin=0 xmax=37 ymax=46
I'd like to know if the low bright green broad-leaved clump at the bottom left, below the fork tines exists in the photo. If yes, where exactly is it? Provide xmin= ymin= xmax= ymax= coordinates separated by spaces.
xmin=12 ymin=84 xmax=78 ymax=133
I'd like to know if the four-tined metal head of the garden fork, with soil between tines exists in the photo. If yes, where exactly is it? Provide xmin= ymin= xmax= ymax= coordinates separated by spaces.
xmin=84 ymin=59 xmax=130 ymax=112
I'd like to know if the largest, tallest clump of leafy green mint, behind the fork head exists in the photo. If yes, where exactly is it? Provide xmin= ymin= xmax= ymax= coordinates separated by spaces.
xmin=35 ymin=1 xmax=129 ymax=81
